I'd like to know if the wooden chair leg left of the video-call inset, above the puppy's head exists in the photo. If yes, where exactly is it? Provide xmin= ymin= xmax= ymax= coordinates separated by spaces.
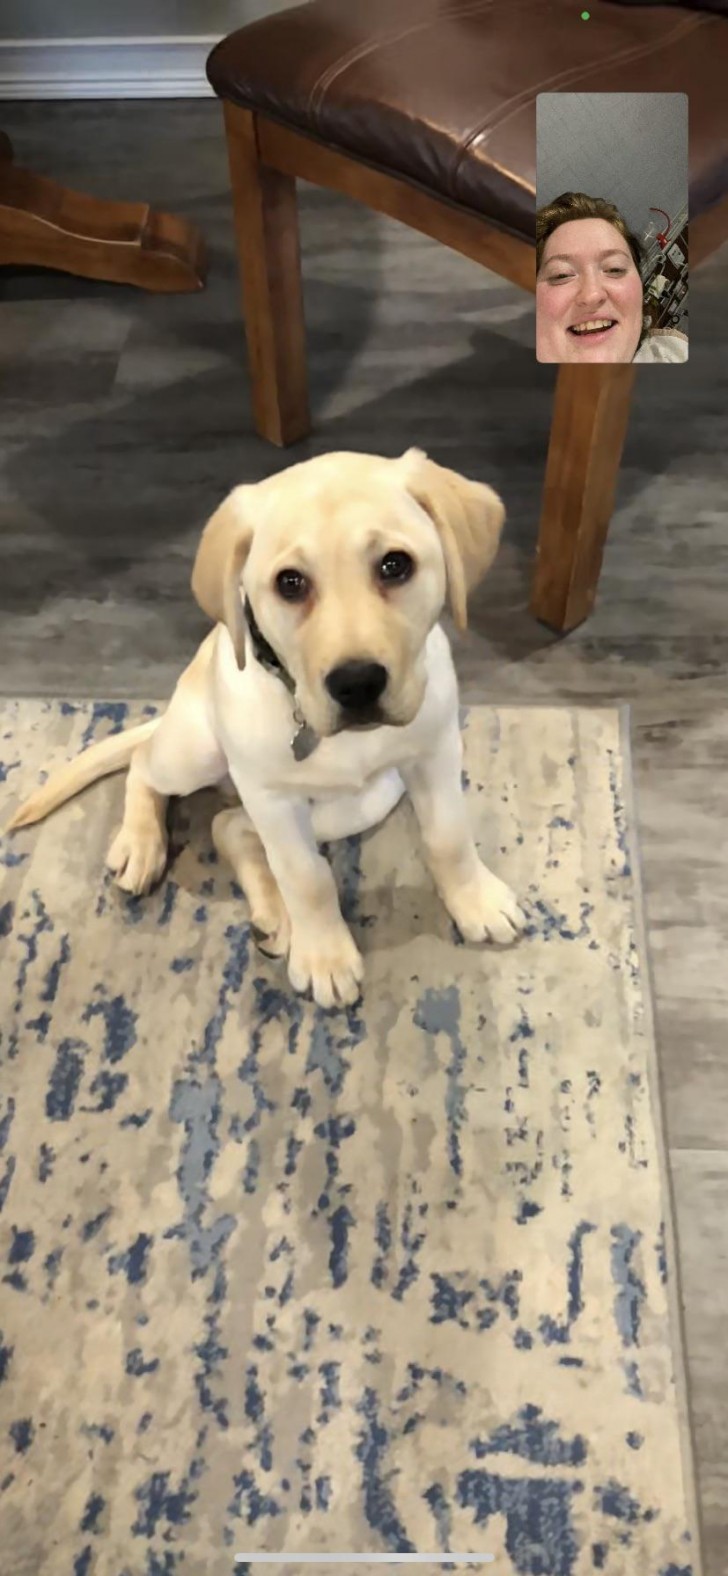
xmin=224 ymin=101 xmax=310 ymax=448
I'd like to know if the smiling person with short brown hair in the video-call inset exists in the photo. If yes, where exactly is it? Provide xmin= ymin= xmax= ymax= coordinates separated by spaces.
xmin=536 ymin=192 xmax=687 ymax=362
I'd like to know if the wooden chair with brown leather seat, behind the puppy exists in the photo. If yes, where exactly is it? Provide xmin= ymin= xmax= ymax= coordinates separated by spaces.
xmin=208 ymin=0 xmax=728 ymax=632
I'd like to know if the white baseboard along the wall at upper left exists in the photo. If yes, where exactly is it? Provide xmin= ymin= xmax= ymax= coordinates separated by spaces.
xmin=0 ymin=35 xmax=221 ymax=99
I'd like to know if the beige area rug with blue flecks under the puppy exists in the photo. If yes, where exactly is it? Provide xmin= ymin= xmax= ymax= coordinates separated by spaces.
xmin=0 ymin=701 xmax=700 ymax=1576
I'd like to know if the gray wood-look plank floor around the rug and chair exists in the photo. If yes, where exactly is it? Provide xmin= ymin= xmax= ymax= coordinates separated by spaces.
xmin=0 ymin=101 xmax=728 ymax=1576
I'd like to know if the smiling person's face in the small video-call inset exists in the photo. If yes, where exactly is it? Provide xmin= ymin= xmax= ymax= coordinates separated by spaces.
xmin=536 ymin=219 xmax=643 ymax=361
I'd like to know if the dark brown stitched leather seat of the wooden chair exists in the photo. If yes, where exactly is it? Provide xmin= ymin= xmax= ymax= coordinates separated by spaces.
xmin=208 ymin=0 xmax=728 ymax=243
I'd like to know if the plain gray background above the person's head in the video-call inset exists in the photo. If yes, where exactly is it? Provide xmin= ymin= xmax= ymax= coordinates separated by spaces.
xmin=536 ymin=93 xmax=687 ymax=245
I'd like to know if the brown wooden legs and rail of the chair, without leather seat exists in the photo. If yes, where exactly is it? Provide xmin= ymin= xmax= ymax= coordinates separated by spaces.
xmin=224 ymin=101 xmax=728 ymax=634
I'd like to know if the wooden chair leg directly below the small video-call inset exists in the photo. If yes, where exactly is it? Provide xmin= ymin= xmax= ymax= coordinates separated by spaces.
xmin=531 ymin=366 xmax=635 ymax=635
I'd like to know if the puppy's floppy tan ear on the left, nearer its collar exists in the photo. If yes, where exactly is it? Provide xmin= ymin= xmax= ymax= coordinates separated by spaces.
xmin=192 ymin=485 xmax=255 ymax=668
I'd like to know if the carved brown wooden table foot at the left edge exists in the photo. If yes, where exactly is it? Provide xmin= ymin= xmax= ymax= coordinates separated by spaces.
xmin=0 ymin=131 xmax=206 ymax=293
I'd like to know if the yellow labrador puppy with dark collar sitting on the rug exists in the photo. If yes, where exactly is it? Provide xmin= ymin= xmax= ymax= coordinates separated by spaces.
xmin=5 ymin=449 xmax=525 ymax=1007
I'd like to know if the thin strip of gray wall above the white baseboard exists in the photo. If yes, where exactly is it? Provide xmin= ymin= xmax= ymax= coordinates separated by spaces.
xmin=0 ymin=0 xmax=293 ymax=39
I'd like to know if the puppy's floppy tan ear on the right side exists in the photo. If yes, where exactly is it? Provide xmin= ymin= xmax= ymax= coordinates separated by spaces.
xmin=394 ymin=449 xmax=506 ymax=629
